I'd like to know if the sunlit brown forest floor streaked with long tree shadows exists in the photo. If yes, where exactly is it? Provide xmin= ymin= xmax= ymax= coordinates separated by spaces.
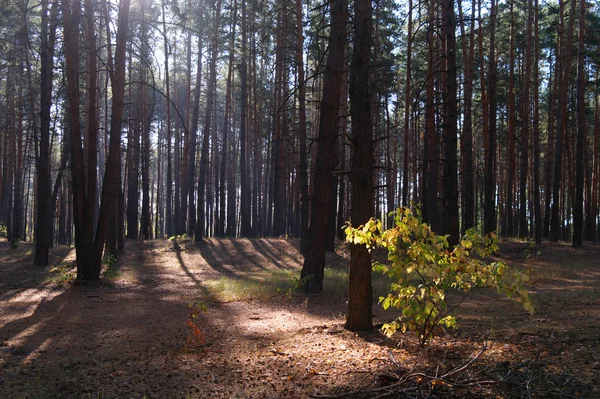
xmin=0 ymin=239 xmax=600 ymax=399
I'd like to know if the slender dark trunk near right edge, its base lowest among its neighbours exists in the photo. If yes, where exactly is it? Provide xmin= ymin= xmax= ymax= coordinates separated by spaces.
xmin=572 ymin=0 xmax=587 ymax=247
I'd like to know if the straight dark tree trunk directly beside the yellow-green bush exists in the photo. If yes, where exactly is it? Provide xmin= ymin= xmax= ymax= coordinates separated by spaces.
xmin=344 ymin=0 xmax=374 ymax=331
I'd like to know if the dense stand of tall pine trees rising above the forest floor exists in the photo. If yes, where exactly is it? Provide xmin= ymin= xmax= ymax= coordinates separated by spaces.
xmin=0 ymin=0 xmax=600 ymax=329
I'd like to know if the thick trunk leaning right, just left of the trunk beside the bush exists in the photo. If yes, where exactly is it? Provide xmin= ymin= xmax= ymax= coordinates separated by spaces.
xmin=301 ymin=0 xmax=346 ymax=292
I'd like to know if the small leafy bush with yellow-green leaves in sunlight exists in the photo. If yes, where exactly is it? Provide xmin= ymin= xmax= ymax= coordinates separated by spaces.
xmin=345 ymin=208 xmax=534 ymax=345
